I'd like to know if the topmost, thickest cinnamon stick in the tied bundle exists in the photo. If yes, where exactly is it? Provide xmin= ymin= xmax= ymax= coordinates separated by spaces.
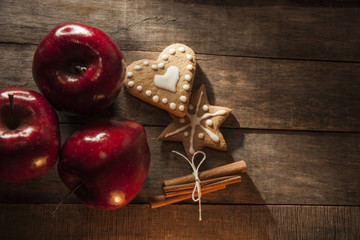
xmin=164 ymin=161 xmax=247 ymax=186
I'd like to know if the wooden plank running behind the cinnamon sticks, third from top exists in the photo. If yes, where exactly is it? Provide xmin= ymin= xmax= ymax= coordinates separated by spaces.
xmin=0 ymin=124 xmax=360 ymax=205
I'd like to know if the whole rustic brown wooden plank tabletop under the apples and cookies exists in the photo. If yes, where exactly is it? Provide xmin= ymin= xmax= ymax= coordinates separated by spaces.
xmin=0 ymin=0 xmax=360 ymax=240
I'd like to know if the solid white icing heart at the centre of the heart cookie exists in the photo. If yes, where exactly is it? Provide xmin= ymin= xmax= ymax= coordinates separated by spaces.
xmin=154 ymin=66 xmax=180 ymax=93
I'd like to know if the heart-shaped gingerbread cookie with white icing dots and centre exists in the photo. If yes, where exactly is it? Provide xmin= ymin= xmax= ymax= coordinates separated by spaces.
xmin=124 ymin=43 xmax=196 ymax=117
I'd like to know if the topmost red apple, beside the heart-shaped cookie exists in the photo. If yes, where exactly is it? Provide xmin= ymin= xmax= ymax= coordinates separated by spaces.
xmin=33 ymin=23 xmax=126 ymax=113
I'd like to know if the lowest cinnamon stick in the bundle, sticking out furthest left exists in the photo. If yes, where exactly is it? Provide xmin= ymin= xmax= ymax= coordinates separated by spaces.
xmin=150 ymin=185 xmax=226 ymax=208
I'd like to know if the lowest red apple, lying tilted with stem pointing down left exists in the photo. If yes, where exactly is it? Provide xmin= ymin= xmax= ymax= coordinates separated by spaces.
xmin=58 ymin=118 xmax=150 ymax=209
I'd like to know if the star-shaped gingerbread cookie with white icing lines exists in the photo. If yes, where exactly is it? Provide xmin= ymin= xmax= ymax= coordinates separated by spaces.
xmin=159 ymin=85 xmax=231 ymax=157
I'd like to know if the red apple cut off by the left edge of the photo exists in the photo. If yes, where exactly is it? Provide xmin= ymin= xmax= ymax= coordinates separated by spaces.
xmin=0 ymin=88 xmax=60 ymax=182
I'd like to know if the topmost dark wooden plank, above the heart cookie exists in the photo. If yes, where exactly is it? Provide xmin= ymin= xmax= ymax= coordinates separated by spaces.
xmin=0 ymin=0 xmax=360 ymax=61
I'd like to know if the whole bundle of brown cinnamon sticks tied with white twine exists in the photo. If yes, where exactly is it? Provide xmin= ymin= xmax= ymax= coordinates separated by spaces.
xmin=149 ymin=161 xmax=247 ymax=208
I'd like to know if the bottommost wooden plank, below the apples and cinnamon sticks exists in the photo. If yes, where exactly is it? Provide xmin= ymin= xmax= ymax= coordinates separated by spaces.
xmin=0 ymin=204 xmax=360 ymax=240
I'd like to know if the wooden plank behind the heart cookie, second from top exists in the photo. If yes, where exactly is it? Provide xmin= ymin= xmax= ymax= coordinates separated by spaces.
xmin=0 ymin=44 xmax=360 ymax=132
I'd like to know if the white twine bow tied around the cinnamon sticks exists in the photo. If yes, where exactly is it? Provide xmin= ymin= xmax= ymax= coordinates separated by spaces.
xmin=172 ymin=150 xmax=206 ymax=221
